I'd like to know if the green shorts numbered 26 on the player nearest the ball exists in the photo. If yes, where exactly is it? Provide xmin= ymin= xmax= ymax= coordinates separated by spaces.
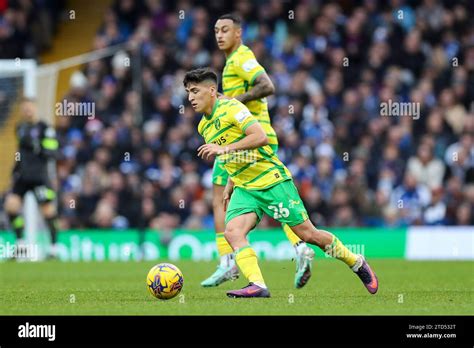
xmin=225 ymin=180 xmax=308 ymax=226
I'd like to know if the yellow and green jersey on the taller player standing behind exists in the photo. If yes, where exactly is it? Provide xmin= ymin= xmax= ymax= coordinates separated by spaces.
xmin=222 ymin=45 xmax=278 ymax=145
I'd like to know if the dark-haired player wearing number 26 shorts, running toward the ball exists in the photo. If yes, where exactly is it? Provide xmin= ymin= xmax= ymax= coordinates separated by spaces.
xmin=183 ymin=68 xmax=378 ymax=298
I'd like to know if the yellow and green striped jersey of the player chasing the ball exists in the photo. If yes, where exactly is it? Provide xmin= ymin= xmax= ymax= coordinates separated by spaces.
xmin=198 ymin=99 xmax=291 ymax=190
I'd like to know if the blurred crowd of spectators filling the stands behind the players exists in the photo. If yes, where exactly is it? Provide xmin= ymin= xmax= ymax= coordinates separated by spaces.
xmin=0 ymin=0 xmax=474 ymax=230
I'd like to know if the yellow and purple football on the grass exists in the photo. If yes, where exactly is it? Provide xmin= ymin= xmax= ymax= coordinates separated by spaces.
xmin=146 ymin=263 xmax=184 ymax=300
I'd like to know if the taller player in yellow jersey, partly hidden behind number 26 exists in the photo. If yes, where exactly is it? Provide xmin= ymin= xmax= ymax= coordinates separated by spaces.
xmin=201 ymin=14 xmax=314 ymax=288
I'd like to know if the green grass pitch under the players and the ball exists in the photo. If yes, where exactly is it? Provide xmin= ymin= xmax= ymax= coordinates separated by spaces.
xmin=0 ymin=259 xmax=474 ymax=315
